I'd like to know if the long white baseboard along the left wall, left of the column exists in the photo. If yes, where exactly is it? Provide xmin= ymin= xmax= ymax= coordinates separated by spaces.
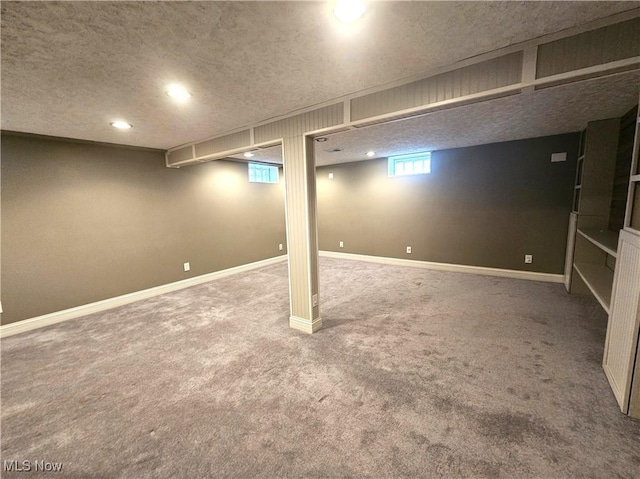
xmin=0 ymin=255 xmax=287 ymax=338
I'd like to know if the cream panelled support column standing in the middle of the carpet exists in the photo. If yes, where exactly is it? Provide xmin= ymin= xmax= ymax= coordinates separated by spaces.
xmin=282 ymin=135 xmax=322 ymax=334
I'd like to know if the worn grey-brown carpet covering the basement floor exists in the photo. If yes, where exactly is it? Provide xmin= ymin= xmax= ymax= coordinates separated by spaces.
xmin=1 ymin=258 xmax=640 ymax=479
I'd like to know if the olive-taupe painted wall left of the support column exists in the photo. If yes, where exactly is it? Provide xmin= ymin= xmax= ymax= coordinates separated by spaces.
xmin=1 ymin=132 xmax=286 ymax=324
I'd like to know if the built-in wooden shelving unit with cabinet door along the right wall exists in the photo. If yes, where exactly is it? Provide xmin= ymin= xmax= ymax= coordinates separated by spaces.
xmin=564 ymin=99 xmax=640 ymax=419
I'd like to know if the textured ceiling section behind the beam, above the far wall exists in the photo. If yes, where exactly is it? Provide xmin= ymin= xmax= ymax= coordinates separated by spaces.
xmin=228 ymin=71 xmax=640 ymax=166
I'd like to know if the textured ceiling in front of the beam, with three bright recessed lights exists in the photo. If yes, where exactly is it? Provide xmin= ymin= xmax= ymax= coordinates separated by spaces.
xmin=1 ymin=1 xmax=638 ymax=149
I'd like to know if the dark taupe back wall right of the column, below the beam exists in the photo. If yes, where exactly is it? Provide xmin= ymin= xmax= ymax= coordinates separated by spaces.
xmin=317 ymin=133 xmax=579 ymax=274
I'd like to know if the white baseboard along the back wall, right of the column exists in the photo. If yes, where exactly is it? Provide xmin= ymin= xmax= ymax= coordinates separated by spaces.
xmin=320 ymin=251 xmax=564 ymax=283
